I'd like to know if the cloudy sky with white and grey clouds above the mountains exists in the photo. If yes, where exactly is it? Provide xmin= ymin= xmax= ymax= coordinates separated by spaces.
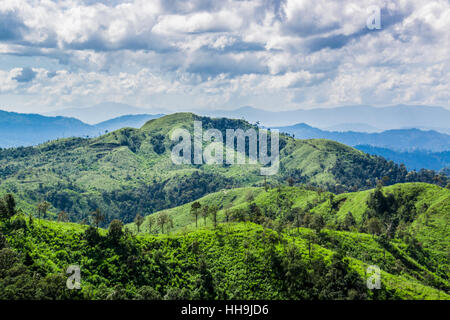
xmin=0 ymin=0 xmax=450 ymax=113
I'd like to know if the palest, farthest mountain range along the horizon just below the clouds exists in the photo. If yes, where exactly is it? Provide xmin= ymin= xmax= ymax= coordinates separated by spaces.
xmin=45 ymin=102 xmax=450 ymax=134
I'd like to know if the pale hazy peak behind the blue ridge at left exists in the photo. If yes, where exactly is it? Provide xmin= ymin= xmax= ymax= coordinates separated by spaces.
xmin=45 ymin=102 xmax=163 ymax=124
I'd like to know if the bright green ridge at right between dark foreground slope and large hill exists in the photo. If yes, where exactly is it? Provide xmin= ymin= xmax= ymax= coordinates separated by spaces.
xmin=127 ymin=183 xmax=450 ymax=298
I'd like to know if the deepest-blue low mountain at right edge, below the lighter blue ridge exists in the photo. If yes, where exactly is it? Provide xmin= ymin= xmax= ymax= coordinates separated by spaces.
xmin=355 ymin=145 xmax=450 ymax=174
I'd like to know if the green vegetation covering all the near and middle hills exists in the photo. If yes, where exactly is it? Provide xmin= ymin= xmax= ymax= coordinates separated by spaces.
xmin=0 ymin=113 xmax=450 ymax=299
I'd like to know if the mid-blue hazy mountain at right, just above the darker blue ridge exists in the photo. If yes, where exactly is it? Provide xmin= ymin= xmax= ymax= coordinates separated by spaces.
xmin=274 ymin=123 xmax=450 ymax=152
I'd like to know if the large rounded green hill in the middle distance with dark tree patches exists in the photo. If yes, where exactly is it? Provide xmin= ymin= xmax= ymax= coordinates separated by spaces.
xmin=0 ymin=113 xmax=447 ymax=224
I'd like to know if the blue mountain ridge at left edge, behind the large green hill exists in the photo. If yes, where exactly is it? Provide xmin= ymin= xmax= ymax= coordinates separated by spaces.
xmin=0 ymin=110 xmax=162 ymax=148
